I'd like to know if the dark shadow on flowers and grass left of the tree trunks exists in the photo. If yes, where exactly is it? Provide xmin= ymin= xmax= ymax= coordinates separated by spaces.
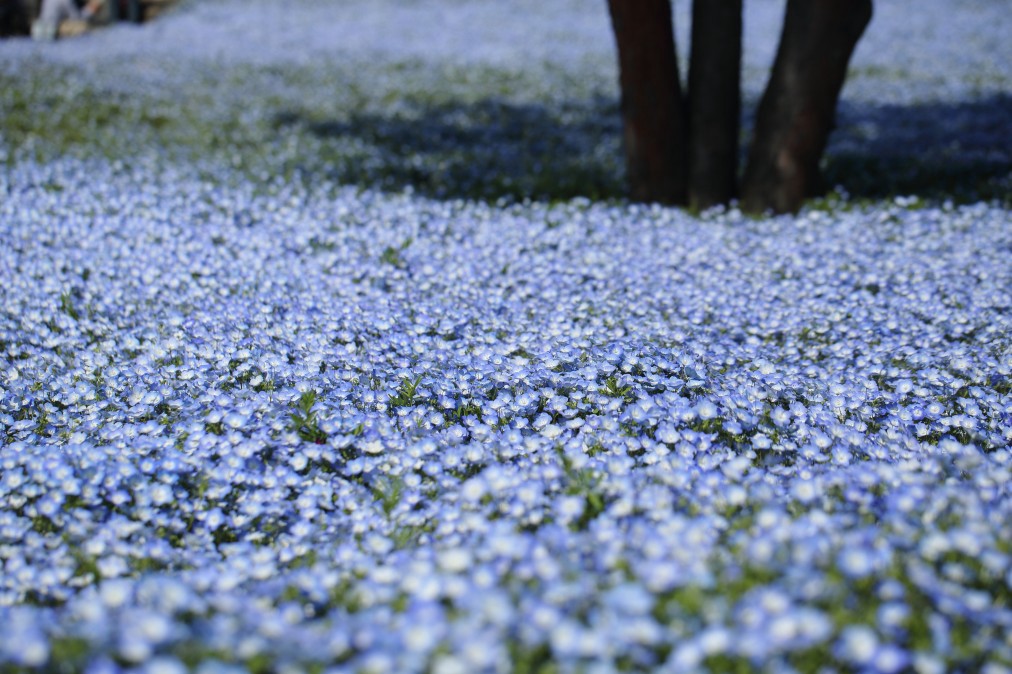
xmin=273 ymin=99 xmax=624 ymax=201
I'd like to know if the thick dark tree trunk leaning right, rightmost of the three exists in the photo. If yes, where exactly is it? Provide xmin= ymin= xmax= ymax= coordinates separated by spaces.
xmin=742 ymin=0 xmax=871 ymax=213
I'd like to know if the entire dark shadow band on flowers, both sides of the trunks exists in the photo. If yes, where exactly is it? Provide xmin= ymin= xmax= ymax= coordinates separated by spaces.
xmin=273 ymin=95 xmax=1012 ymax=202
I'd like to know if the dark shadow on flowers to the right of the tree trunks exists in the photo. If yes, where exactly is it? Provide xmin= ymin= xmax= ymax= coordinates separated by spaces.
xmin=826 ymin=94 xmax=1012 ymax=203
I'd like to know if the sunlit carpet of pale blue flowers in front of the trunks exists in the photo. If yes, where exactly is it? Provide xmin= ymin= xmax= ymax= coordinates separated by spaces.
xmin=0 ymin=154 xmax=1012 ymax=671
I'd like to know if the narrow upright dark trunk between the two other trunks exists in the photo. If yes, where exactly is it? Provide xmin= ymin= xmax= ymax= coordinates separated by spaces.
xmin=688 ymin=0 xmax=742 ymax=208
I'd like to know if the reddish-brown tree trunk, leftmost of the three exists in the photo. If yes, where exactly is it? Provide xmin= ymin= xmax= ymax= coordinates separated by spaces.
xmin=608 ymin=0 xmax=686 ymax=204
